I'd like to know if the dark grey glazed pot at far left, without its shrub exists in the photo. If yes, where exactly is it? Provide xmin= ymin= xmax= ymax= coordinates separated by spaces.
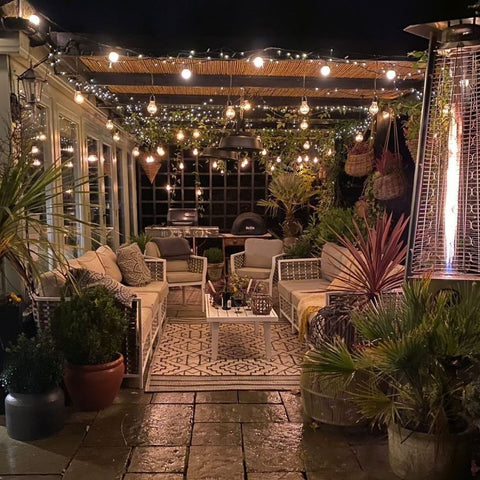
xmin=5 ymin=387 xmax=65 ymax=441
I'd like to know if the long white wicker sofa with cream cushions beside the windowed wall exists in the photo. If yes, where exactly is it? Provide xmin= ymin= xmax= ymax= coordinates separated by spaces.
xmin=32 ymin=245 xmax=168 ymax=388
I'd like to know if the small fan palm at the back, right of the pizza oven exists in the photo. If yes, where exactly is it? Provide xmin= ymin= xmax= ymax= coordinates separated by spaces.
xmin=257 ymin=172 xmax=319 ymax=237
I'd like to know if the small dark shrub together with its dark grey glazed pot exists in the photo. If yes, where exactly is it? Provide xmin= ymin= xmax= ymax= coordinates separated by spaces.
xmin=0 ymin=333 xmax=65 ymax=440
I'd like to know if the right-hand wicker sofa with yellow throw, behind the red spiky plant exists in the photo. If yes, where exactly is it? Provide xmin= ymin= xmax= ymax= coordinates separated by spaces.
xmin=278 ymin=242 xmax=358 ymax=336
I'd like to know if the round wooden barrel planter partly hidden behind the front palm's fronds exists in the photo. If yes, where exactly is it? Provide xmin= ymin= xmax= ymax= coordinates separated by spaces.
xmin=300 ymin=371 xmax=366 ymax=426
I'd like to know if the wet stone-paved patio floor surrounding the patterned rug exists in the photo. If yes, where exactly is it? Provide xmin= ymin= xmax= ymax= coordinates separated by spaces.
xmin=0 ymin=288 xmax=458 ymax=480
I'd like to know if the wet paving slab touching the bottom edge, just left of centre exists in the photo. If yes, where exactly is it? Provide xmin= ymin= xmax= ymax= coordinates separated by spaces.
xmin=187 ymin=446 xmax=244 ymax=480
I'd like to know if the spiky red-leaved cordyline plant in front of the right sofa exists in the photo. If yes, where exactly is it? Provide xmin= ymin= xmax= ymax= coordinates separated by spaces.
xmin=334 ymin=212 xmax=408 ymax=300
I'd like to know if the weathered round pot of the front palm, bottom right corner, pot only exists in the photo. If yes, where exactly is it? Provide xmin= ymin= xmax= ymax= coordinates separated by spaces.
xmin=388 ymin=425 xmax=472 ymax=480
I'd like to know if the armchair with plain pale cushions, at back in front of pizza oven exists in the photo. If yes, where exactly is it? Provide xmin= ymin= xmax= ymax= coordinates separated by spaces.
xmin=230 ymin=238 xmax=284 ymax=296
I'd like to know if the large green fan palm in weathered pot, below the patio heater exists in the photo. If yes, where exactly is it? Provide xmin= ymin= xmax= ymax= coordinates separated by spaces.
xmin=303 ymin=279 xmax=480 ymax=480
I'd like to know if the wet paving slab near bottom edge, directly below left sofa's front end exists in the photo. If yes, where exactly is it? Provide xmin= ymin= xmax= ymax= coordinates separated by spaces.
xmin=128 ymin=447 xmax=187 ymax=473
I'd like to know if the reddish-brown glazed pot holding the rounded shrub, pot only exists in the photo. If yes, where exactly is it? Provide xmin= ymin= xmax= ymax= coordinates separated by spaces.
xmin=63 ymin=353 xmax=125 ymax=411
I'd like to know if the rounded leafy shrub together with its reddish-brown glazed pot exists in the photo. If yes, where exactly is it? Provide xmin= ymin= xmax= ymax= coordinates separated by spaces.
xmin=51 ymin=285 xmax=128 ymax=411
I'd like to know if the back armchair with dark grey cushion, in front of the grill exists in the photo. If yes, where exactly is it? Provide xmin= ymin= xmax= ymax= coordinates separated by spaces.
xmin=145 ymin=237 xmax=207 ymax=312
